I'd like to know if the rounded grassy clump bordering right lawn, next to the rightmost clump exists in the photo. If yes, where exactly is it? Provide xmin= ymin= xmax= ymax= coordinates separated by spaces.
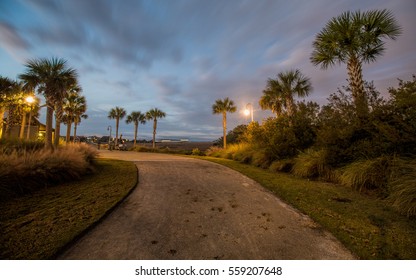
xmin=340 ymin=157 xmax=392 ymax=194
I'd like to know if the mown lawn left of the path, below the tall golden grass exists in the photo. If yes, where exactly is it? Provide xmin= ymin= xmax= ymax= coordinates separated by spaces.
xmin=0 ymin=159 xmax=138 ymax=259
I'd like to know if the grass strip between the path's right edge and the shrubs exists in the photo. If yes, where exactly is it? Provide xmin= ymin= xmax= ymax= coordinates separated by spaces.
xmin=199 ymin=157 xmax=416 ymax=260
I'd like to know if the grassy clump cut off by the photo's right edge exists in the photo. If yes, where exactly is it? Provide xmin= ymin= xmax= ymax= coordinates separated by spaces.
xmin=388 ymin=159 xmax=416 ymax=217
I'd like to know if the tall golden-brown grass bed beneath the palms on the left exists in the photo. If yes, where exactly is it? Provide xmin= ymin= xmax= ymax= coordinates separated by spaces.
xmin=0 ymin=145 xmax=97 ymax=200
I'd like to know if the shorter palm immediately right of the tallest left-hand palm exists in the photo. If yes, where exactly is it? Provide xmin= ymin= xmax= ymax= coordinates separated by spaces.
xmin=63 ymin=91 xmax=87 ymax=143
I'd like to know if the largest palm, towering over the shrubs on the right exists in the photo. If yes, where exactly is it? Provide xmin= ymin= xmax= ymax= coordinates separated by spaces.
xmin=310 ymin=10 xmax=401 ymax=119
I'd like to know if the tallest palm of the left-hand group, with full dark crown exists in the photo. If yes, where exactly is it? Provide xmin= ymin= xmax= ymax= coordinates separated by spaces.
xmin=19 ymin=58 xmax=78 ymax=148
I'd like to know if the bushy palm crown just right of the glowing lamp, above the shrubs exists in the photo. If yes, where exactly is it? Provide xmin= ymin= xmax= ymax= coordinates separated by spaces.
xmin=259 ymin=69 xmax=312 ymax=116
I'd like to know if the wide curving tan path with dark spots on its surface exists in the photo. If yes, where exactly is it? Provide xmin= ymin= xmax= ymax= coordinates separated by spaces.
xmin=60 ymin=151 xmax=353 ymax=259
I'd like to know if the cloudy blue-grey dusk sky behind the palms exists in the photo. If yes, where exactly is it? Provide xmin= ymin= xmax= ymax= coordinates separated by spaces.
xmin=0 ymin=0 xmax=416 ymax=141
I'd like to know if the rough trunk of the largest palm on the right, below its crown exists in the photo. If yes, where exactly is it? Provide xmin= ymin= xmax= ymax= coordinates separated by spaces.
xmin=347 ymin=56 xmax=369 ymax=121
